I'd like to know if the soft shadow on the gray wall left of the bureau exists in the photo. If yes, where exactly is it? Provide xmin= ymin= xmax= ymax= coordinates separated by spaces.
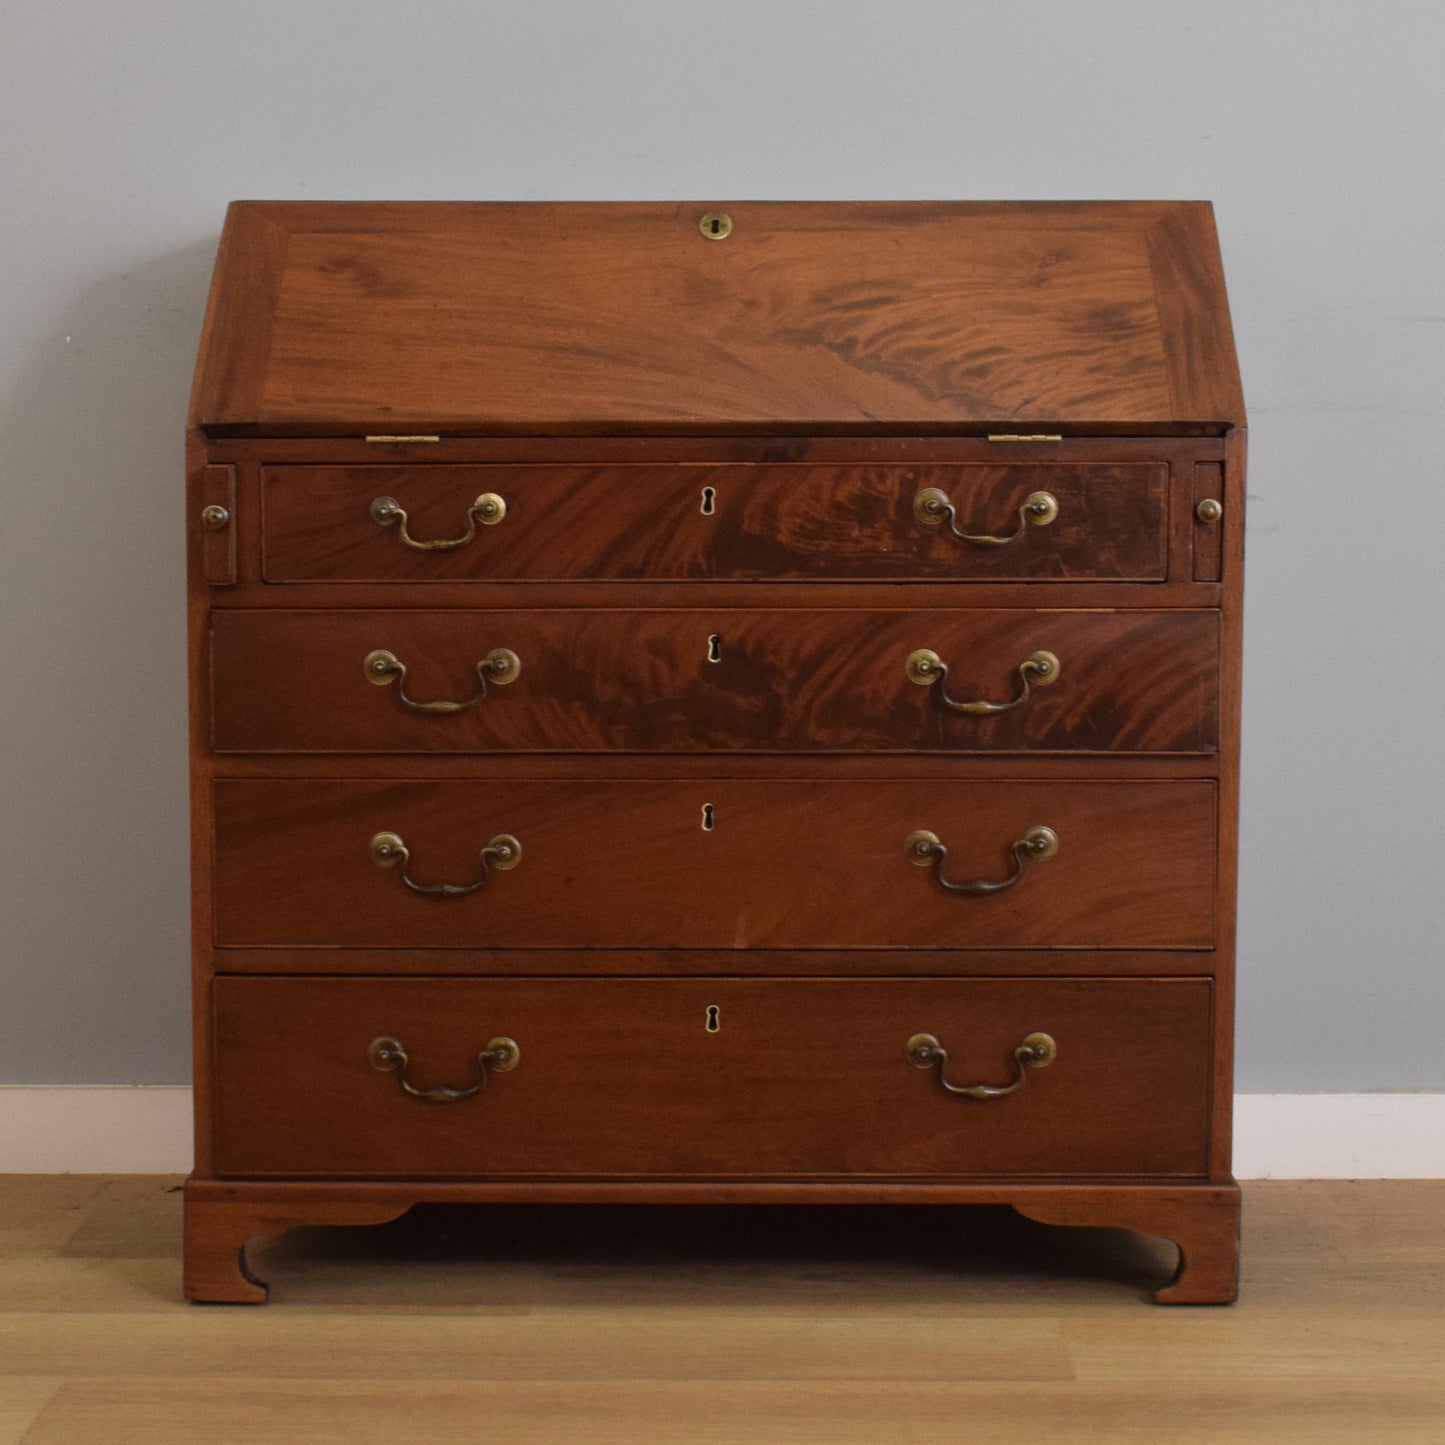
xmin=0 ymin=236 xmax=217 ymax=1084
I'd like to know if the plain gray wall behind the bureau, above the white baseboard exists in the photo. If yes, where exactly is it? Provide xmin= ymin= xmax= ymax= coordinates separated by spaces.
xmin=0 ymin=0 xmax=1445 ymax=1090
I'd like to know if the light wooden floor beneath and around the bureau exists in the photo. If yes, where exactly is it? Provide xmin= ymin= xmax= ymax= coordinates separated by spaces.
xmin=0 ymin=1175 xmax=1445 ymax=1445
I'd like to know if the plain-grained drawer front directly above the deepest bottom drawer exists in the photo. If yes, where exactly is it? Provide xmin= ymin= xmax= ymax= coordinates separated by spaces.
xmin=214 ymin=779 xmax=1215 ymax=949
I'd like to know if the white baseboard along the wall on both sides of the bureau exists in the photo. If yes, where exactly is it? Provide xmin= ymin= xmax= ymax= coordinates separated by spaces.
xmin=0 ymin=1085 xmax=1445 ymax=1179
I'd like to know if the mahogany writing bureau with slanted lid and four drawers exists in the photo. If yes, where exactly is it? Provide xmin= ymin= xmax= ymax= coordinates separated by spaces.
xmin=185 ymin=202 xmax=1244 ymax=1302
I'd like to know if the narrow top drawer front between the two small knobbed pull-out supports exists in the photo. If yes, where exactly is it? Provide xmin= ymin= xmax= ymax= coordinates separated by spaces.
xmin=262 ymin=462 xmax=1168 ymax=582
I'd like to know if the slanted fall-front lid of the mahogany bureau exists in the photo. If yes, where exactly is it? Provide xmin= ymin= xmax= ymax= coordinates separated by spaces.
xmin=191 ymin=201 xmax=1244 ymax=436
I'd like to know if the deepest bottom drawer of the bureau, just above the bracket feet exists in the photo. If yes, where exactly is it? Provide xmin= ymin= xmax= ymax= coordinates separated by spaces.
xmin=212 ymin=977 xmax=1211 ymax=1178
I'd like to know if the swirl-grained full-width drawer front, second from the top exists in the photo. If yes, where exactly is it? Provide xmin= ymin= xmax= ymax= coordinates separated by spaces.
xmin=211 ymin=608 xmax=1220 ymax=753
